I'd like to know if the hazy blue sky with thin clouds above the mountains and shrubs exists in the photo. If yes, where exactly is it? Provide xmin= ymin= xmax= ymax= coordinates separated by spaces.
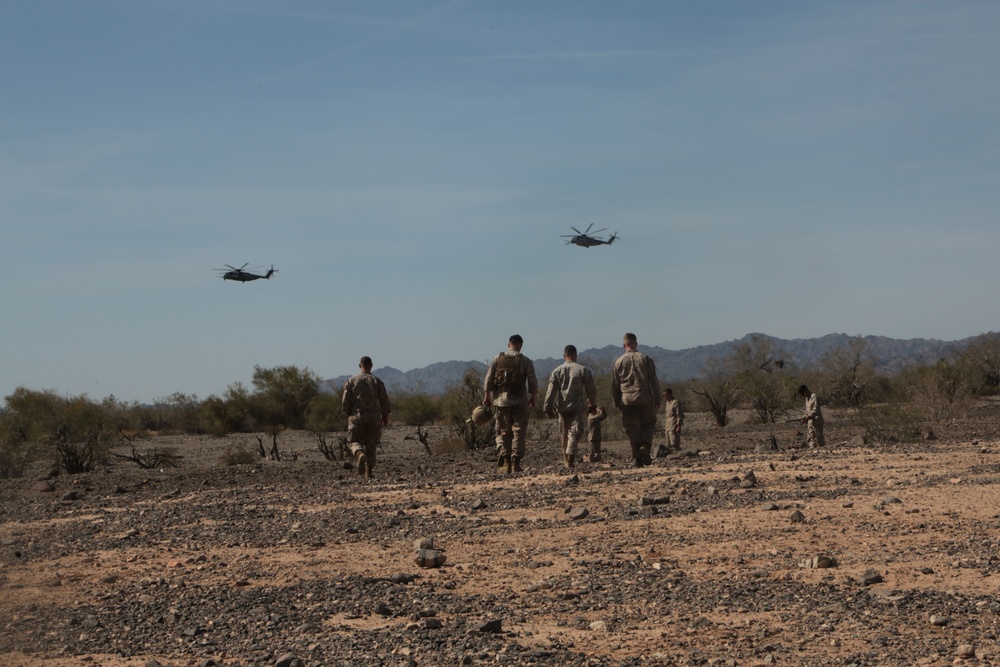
xmin=0 ymin=0 xmax=1000 ymax=401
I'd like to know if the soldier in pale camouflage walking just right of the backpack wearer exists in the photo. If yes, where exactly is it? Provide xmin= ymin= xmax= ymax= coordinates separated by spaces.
xmin=544 ymin=345 xmax=597 ymax=468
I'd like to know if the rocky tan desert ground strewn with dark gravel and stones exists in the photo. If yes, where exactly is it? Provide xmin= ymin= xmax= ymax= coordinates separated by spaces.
xmin=0 ymin=403 xmax=1000 ymax=667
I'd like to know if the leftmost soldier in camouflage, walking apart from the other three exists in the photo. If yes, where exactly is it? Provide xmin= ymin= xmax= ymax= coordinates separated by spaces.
xmin=343 ymin=357 xmax=392 ymax=478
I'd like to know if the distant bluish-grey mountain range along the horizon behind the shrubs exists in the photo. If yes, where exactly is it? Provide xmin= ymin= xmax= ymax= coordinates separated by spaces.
xmin=324 ymin=333 xmax=973 ymax=394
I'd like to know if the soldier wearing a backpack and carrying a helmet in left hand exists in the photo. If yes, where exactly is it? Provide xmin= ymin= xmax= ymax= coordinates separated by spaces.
xmin=483 ymin=334 xmax=538 ymax=474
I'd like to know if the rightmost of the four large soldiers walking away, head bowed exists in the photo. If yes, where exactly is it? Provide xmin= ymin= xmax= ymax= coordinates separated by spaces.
xmin=611 ymin=333 xmax=660 ymax=468
